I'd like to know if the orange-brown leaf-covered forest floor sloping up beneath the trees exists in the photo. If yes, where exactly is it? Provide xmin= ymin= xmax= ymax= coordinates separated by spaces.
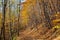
xmin=16 ymin=25 xmax=60 ymax=40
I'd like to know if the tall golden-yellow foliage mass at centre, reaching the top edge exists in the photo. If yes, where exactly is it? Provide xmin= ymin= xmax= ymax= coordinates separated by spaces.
xmin=21 ymin=0 xmax=36 ymax=25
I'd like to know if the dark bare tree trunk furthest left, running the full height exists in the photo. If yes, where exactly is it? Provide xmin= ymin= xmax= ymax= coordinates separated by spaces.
xmin=2 ymin=0 xmax=7 ymax=40
